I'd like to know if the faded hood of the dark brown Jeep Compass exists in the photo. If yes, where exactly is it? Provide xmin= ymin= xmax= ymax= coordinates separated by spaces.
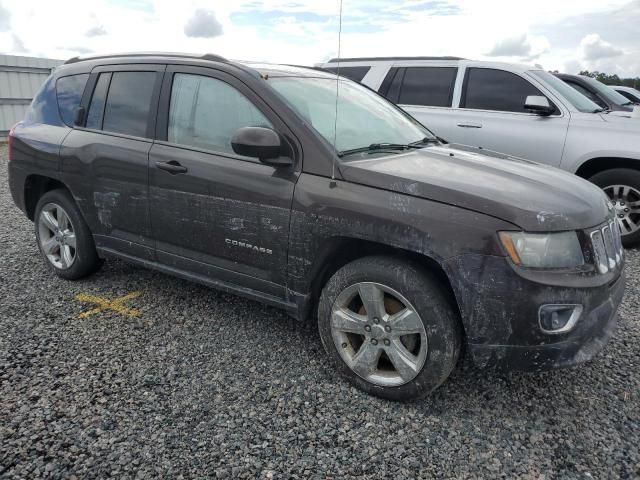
xmin=341 ymin=145 xmax=611 ymax=232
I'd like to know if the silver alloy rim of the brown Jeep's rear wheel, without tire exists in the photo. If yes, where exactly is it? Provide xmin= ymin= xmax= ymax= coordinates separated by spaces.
xmin=38 ymin=203 xmax=76 ymax=270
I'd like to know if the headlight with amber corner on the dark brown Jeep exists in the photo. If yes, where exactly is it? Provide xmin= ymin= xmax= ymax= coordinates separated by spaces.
xmin=498 ymin=232 xmax=584 ymax=268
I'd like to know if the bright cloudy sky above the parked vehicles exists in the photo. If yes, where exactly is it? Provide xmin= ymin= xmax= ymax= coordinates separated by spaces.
xmin=0 ymin=0 xmax=640 ymax=77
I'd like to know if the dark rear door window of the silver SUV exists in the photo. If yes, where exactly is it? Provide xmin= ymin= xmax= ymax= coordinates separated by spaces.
xmin=398 ymin=67 xmax=458 ymax=107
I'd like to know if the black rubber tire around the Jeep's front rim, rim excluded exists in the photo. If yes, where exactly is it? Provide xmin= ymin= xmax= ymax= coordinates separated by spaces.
xmin=318 ymin=257 xmax=461 ymax=401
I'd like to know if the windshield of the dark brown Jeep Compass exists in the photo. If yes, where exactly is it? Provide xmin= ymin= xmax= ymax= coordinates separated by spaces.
xmin=269 ymin=77 xmax=435 ymax=152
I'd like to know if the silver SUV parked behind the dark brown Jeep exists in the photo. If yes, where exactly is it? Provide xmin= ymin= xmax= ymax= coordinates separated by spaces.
xmin=318 ymin=57 xmax=640 ymax=246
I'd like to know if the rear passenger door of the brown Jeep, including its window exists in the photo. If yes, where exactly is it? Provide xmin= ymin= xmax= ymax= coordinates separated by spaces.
xmin=60 ymin=64 xmax=165 ymax=260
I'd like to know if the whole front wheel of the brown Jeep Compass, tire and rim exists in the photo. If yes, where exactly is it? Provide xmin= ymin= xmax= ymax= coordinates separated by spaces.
xmin=318 ymin=257 xmax=462 ymax=401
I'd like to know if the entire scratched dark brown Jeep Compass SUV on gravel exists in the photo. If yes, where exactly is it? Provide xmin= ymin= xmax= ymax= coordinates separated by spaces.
xmin=9 ymin=54 xmax=624 ymax=399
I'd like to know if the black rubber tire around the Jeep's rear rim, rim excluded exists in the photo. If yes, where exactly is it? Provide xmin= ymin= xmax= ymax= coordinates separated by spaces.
xmin=34 ymin=190 xmax=102 ymax=280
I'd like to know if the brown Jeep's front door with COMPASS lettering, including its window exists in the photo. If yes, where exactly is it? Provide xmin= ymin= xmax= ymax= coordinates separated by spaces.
xmin=149 ymin=66 xmax=298 ymax=296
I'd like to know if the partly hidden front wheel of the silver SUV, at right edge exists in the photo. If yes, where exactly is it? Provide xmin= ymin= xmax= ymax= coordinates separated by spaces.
xmin=589 ymin=168 xmax=640 ymax=248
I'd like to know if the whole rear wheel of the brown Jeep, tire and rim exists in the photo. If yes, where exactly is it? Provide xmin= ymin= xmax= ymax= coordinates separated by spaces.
xmin=34 ymin=189 xmax=102 ymax=280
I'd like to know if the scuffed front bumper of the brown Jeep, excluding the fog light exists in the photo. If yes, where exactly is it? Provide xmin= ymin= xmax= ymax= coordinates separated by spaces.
xmin=450 ymin=256 xmax=625 ymax=371
